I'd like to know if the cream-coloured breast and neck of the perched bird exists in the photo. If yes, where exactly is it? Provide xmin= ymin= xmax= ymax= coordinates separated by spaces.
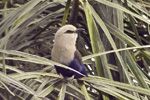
xmin=51 ymin=34 xmax=77 ymax=65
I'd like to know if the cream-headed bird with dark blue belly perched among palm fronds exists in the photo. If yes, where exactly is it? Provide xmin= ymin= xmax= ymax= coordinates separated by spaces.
xmin=51 ymin=24 xmax=88 ymax=79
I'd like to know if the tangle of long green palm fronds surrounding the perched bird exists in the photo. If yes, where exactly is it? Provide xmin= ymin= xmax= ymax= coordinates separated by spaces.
xmin=0 ymin=0 xmax=150 ymax=100
